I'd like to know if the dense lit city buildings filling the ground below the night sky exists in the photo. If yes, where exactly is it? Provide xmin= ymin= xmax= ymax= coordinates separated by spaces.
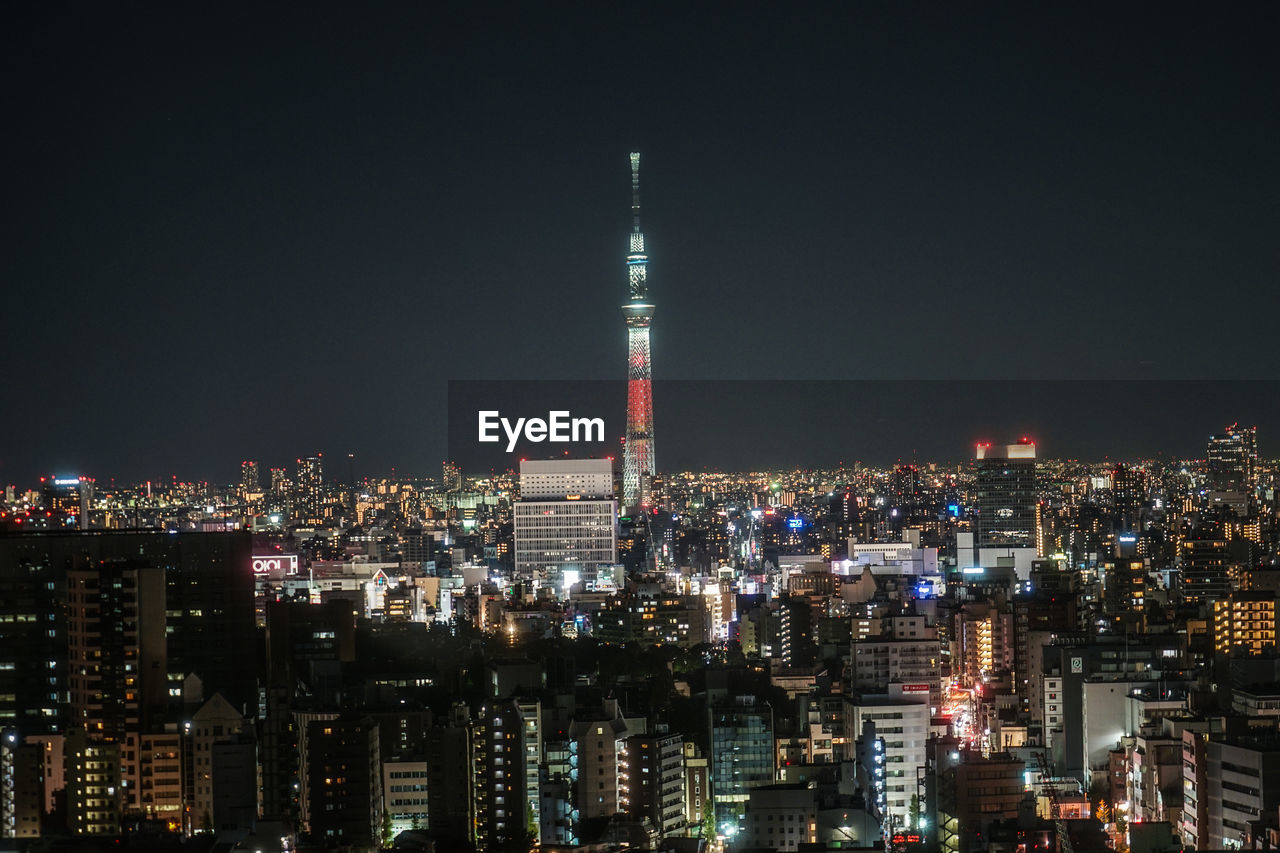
xmin=0 ymin=427 xmax=1280 ymax=852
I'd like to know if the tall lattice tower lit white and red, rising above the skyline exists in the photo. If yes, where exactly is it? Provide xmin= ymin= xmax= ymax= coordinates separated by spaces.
xmin=622 ymin=152 xmax=654 ymax=511
